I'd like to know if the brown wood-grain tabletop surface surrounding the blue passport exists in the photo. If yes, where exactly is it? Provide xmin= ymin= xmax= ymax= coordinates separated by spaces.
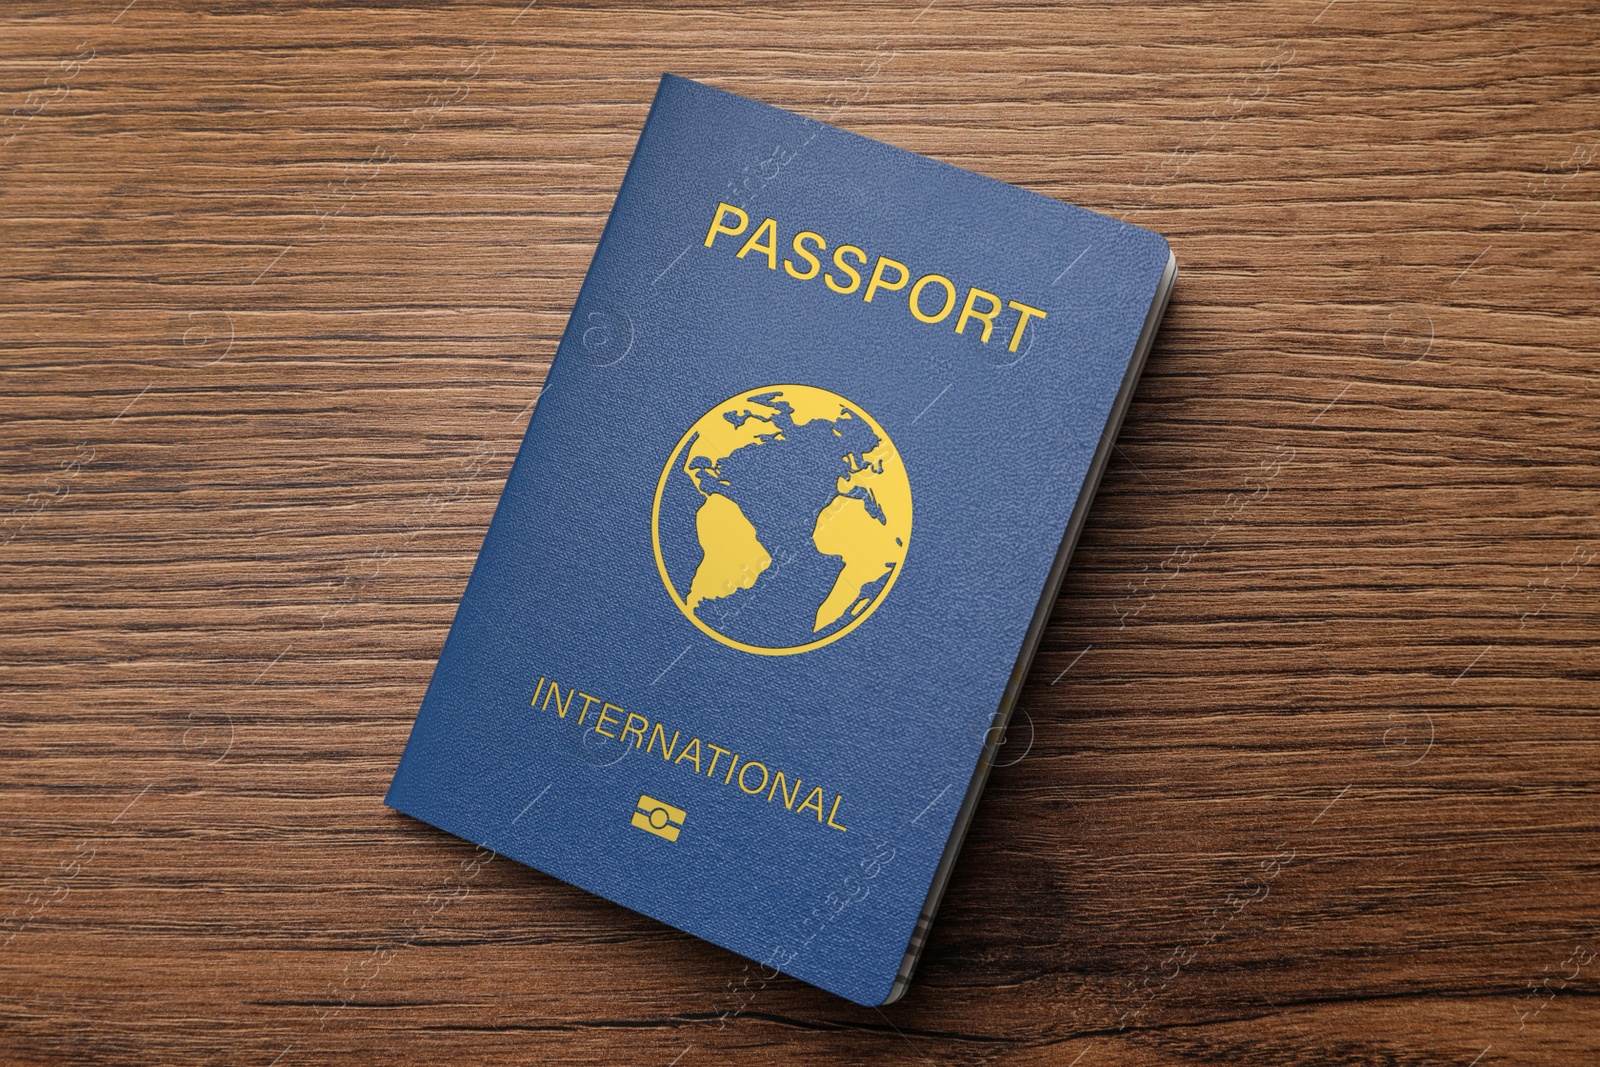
xmin=0 ymin=0 xmax=1600 ymax=1067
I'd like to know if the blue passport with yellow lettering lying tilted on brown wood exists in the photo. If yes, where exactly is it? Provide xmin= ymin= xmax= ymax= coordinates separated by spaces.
xmin=387 ymin=75 xmax=1170 ymax=1005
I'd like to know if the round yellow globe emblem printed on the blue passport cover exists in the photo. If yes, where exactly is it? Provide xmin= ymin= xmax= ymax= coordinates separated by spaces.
xmin=650 ymin=386 xmax=910 ymax=656
